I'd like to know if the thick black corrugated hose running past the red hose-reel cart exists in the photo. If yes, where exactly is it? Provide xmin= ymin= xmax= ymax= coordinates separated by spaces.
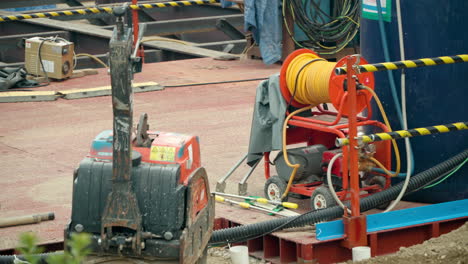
xmin=210 ymin=149 xmax=468 ymax=245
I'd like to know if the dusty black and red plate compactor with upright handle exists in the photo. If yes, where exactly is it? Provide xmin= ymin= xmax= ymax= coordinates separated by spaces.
xmin=65 ymin=8 xmax=214 ymax=263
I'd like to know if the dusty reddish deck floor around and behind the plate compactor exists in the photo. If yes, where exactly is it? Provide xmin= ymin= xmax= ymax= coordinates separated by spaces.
xmin=0 ymin=58 xmax=466 ymax=263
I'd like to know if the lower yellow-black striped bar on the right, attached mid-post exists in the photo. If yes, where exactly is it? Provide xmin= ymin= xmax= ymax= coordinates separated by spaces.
xmin=336 ymin=122 xmax=468 ymax=147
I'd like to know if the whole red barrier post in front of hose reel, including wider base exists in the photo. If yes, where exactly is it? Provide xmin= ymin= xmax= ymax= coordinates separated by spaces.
xmin=343 ymin=56 xmax=367 ymax=248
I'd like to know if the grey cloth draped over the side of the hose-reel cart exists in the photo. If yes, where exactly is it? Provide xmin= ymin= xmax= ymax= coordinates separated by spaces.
xmin=247 ymin=74 xmax=286 ymax=165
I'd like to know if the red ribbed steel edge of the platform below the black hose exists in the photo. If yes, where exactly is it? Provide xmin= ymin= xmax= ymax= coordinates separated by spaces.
xmin=214 ymin=214 xmax=468 ymax=264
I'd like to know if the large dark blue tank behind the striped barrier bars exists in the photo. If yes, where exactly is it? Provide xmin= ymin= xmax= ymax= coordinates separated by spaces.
xmin=361 ymin=0 xmax=468 ymax=203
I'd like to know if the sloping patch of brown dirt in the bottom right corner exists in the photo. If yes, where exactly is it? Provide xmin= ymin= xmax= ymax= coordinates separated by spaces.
xmin=347 ymin=222 xmax=468 ymax=264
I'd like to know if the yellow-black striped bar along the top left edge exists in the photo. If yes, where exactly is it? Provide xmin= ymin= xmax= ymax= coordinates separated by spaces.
xmin=0 ymin=0 xmax=220 ymax=22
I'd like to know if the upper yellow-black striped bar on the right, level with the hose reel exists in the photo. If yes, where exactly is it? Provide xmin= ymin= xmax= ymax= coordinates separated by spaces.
xmin=335 ymin=54 xmax=468 ymax=75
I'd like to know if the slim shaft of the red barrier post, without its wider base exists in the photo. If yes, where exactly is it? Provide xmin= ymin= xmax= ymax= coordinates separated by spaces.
xmin=346 ymin=56 xmax=361 ymax=217
